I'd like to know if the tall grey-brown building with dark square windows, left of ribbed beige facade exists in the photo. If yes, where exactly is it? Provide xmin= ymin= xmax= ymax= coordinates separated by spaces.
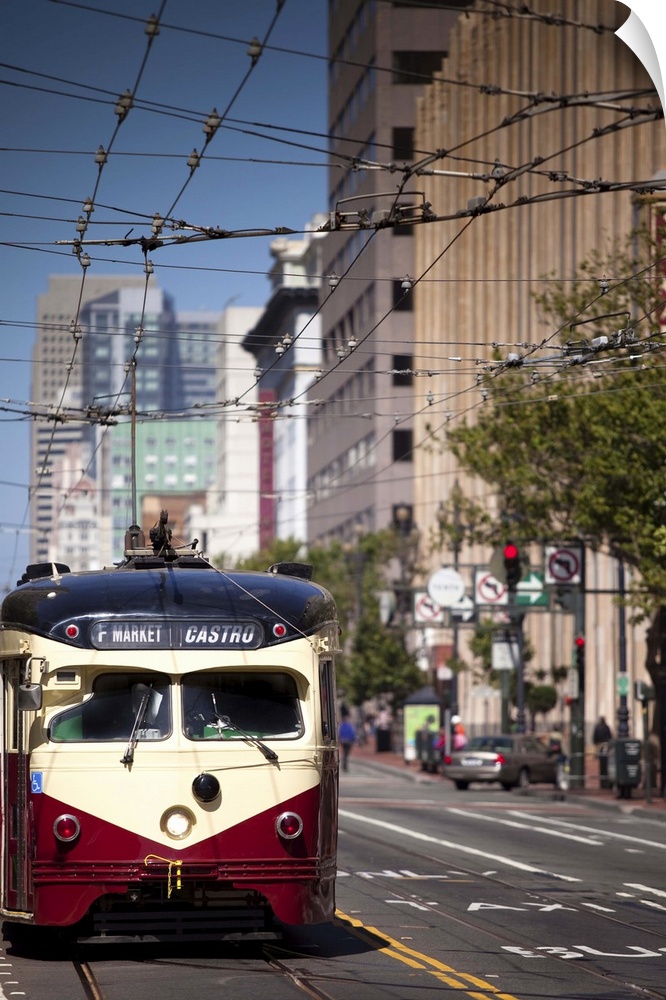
xmin=307 ymin=0 xmax=471 ymax=542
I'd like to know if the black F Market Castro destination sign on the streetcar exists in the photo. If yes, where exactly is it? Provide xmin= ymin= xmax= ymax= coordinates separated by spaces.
xmin=90 ymin=619 xmax=263 ymax=649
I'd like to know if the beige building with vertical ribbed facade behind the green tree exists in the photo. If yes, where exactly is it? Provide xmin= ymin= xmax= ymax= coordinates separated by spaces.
xmin=414 ymin=0 xmax=666 ymax=739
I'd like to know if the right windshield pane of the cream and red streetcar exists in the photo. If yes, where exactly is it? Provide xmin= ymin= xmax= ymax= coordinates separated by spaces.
xmin=181 ymin=671 xmax=303 ymax=740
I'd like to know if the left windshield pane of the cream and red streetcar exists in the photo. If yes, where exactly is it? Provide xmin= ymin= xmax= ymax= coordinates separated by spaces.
xmin=49 ymin=673 xmax=171 ymax=743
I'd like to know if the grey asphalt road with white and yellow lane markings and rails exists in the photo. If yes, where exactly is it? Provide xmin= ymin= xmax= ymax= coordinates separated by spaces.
xmin=5 ymin=755 xmax=666 ymax=1000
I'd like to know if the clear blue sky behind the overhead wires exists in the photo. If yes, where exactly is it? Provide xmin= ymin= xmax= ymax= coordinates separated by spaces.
xmin=0 ymin=0 xmax=666 ymax=592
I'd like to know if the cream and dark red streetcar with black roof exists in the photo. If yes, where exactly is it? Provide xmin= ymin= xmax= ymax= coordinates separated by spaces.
xmin=0 ymin=511 xmax=339 ymax=946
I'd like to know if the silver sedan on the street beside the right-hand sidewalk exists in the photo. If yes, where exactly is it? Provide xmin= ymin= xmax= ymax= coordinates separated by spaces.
xmin=442 ymin=733 xmax=560 ymax=791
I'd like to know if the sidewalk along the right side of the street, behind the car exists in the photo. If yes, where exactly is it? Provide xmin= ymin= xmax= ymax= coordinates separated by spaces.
xmin=350 ymin=738 xmax=666 ymax=821
